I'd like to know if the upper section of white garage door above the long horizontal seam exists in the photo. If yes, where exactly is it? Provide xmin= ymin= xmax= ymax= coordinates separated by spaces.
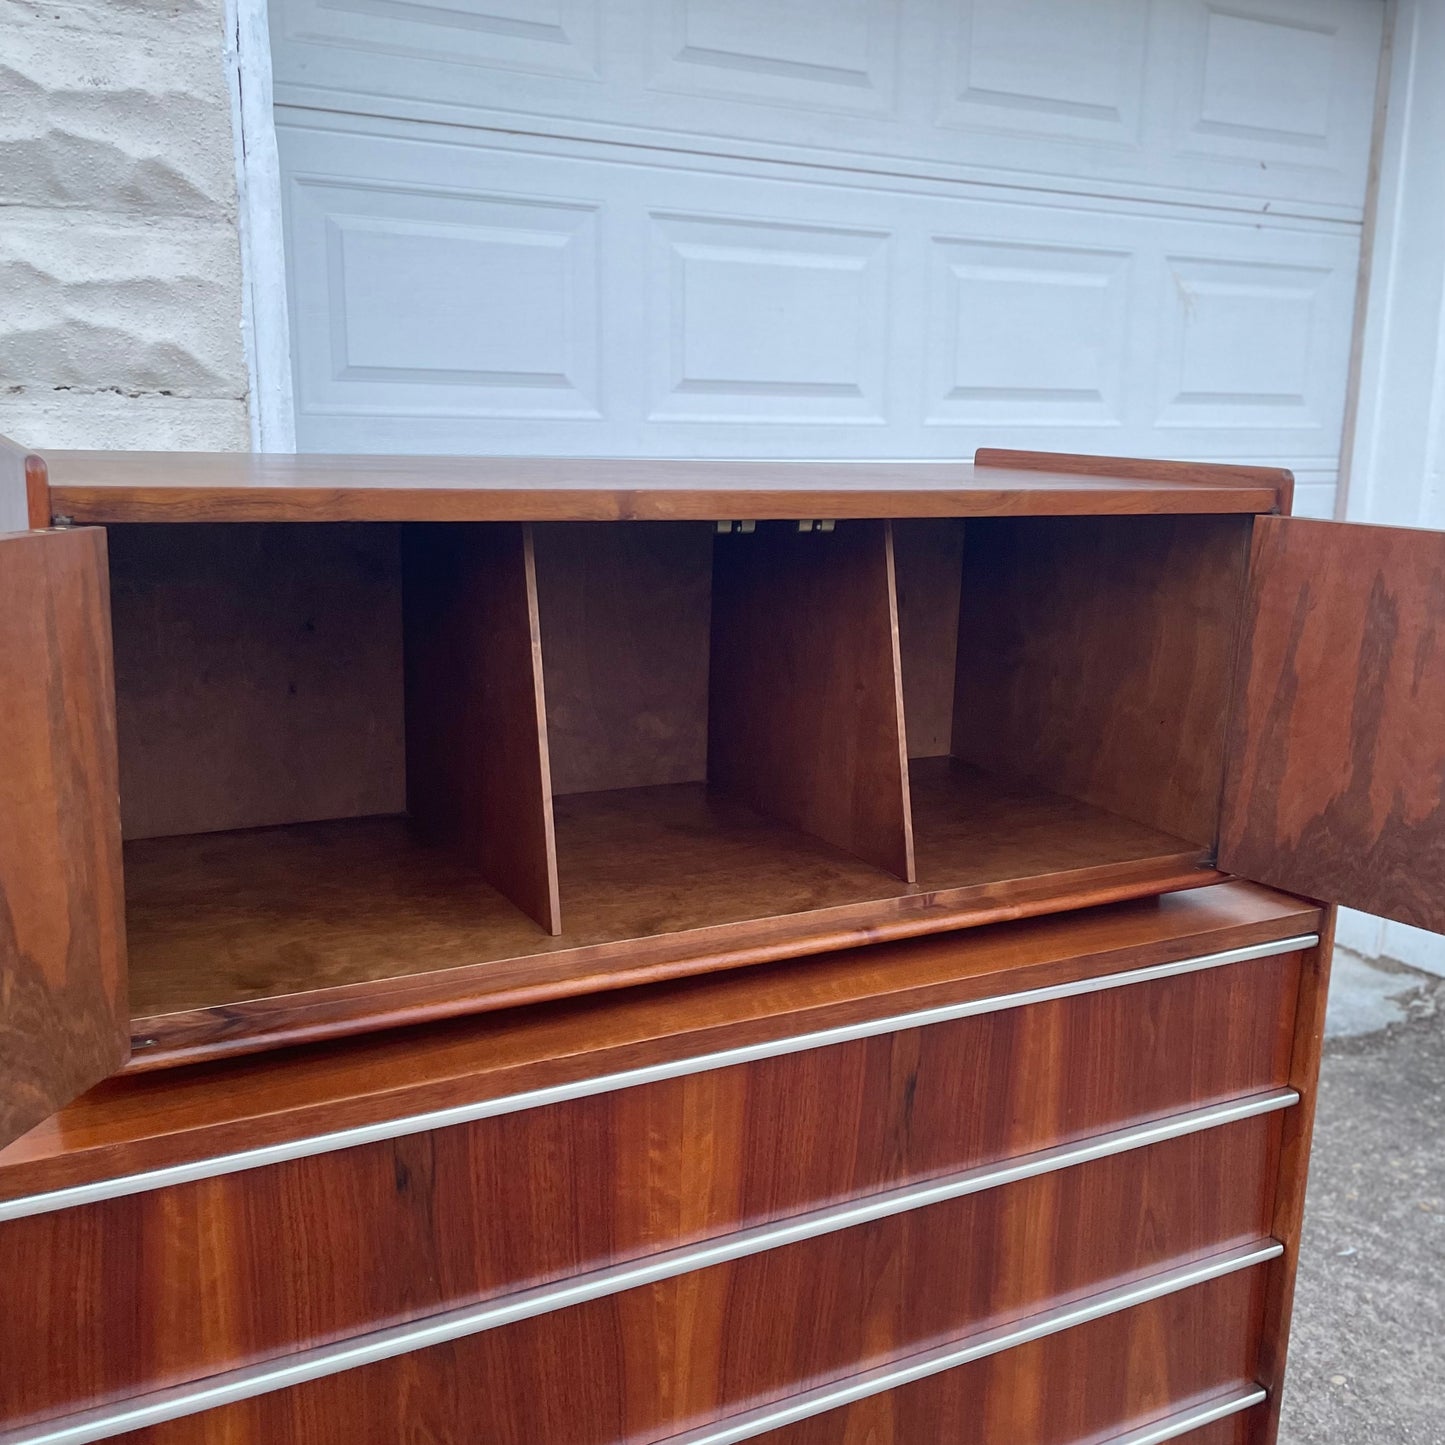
xmin=272 ymin=0 xmax=1384 ymax=220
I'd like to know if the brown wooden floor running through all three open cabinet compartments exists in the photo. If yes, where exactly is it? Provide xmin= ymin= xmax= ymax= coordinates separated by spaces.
xmin=126 ymin=759 xmax=1208 ymax=1035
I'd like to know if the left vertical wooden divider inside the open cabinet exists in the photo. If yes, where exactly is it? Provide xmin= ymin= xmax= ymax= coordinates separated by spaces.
xmin=402 ymin=522 xmax=562 ymax=933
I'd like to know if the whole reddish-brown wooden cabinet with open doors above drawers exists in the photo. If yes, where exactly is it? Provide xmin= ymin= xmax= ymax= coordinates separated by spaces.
xmin=0 ymin=439 xmax=1427 ymax=1445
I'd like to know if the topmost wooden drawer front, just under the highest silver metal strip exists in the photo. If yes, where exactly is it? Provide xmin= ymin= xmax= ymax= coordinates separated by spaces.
xmin=0 ymin=955 xmax=1299 ymax=1425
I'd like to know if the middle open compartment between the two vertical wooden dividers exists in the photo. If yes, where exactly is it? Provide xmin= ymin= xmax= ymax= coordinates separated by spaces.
xmin=536 ymin=522 xmax=909 ymax=942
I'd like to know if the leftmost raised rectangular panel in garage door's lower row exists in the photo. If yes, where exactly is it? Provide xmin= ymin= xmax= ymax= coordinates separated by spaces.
xmin=290 ymin=184 xmax=601 ymax=420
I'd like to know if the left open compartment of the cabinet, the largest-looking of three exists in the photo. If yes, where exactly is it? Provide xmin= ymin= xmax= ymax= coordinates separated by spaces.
xmin=108 ymin=523 xmax=555 ymax=1032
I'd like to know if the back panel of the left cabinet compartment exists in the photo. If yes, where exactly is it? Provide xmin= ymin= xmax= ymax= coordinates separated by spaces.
xmin=108 ymin=523 xmax=406 ymax=838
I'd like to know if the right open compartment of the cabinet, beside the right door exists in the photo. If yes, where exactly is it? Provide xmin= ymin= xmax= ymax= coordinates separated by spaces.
xmin=893 ymin=516 xmax=1251 ymax=887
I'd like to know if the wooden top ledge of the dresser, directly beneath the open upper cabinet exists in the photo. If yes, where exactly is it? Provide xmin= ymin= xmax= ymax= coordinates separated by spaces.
xmin=0 ymin=883 xmax=1319 ymax=1198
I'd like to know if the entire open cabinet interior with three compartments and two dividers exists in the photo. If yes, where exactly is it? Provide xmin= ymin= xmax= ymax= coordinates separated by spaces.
xmin=108 ymin=514 xmax=1250 ymax=1068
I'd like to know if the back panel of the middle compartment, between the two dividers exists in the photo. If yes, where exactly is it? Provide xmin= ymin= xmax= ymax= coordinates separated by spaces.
xmin=533 ymin=522 xmax=712 ymax=793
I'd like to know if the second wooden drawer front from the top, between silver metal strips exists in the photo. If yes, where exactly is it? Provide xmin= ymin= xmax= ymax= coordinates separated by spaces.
xmin=93 ymin=1114 xmax=1280 ymax=1445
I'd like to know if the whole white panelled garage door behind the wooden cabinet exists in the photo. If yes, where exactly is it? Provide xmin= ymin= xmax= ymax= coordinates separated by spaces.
xmin=272 ymin=0 xmax=1383 ymax=520
